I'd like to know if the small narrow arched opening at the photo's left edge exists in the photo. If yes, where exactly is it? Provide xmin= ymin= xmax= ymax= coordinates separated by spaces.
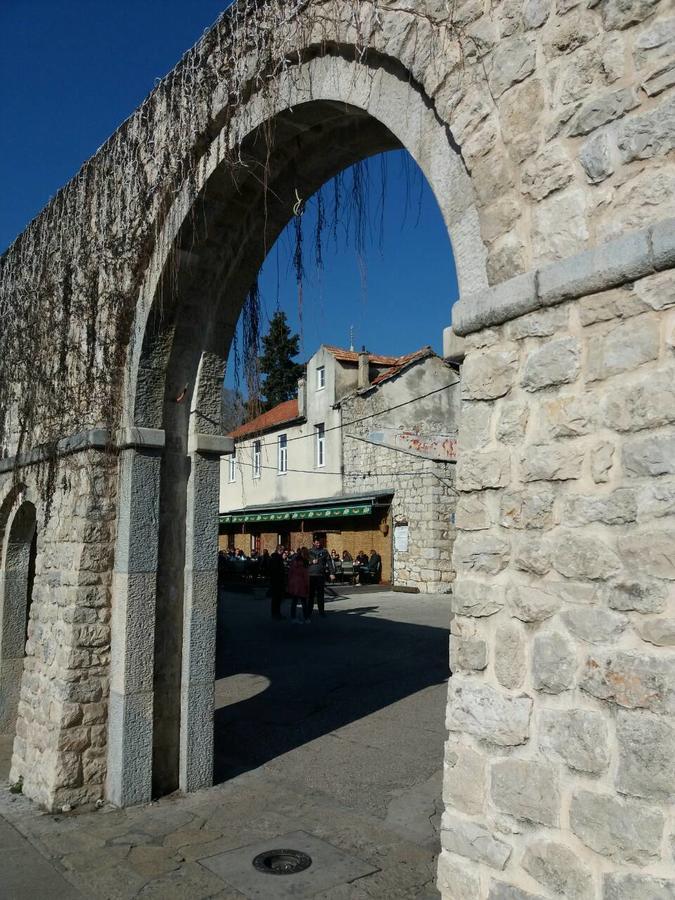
xmin=0 ymin=489 xmax=37 ymax=735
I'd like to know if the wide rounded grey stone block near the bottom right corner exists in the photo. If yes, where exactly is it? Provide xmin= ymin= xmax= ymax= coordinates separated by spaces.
xmin=570 ymin=791 xmax=664 ymax=865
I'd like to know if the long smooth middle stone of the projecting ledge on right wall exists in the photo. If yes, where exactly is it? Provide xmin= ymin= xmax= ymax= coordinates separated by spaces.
xmin=539 ymin=229 xmax=653 ymax=305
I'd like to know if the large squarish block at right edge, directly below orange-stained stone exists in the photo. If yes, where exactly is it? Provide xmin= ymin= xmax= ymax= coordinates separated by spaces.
xmin=616 ymin=710 xmax=675 ymax=801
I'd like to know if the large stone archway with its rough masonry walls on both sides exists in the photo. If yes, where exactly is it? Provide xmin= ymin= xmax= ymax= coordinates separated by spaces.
xmin=0 ymin=0 xmax=675 ymax=898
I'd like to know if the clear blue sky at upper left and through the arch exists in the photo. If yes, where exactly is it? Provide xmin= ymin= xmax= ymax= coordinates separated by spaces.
xmin=0 ymin=0 xmax=457 ymax=374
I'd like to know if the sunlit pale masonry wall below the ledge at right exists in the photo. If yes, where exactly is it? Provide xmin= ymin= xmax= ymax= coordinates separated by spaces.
xmin=439 ymin=268 xmax=675 ymax=900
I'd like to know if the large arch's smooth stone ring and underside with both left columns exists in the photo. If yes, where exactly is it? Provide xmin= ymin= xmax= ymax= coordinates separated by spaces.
xmin=108 ymin=48 xmax=480 ymax=803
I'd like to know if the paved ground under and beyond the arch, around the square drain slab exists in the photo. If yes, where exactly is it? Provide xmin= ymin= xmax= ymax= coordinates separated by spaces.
xmin=0 ymin=589 xmax=449 ymax=900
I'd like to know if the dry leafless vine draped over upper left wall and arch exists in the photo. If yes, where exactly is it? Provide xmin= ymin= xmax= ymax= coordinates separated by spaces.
xmin=0 ymin=0 xmax=460 ymax=510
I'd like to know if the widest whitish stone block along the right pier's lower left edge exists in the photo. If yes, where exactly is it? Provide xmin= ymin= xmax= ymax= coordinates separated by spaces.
xmin=446 ymin=678 xmax=532 ymax=747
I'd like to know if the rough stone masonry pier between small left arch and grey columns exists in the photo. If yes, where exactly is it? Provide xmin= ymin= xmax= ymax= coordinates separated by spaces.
xmin=0 ymin=451 xmax=116 ymax=809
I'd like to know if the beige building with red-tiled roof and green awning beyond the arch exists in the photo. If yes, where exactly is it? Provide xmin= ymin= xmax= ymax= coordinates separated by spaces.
xmin=220 ymin=346 xmax=459 ymax=591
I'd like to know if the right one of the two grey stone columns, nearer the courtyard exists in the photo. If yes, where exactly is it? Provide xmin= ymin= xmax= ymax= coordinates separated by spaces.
xmin=179 ymin=434 xmax=232 ymax=793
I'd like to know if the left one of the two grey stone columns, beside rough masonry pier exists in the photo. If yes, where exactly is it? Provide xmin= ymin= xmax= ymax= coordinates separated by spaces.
xmin=106 ymin=428 xmax=164 ymax=806
